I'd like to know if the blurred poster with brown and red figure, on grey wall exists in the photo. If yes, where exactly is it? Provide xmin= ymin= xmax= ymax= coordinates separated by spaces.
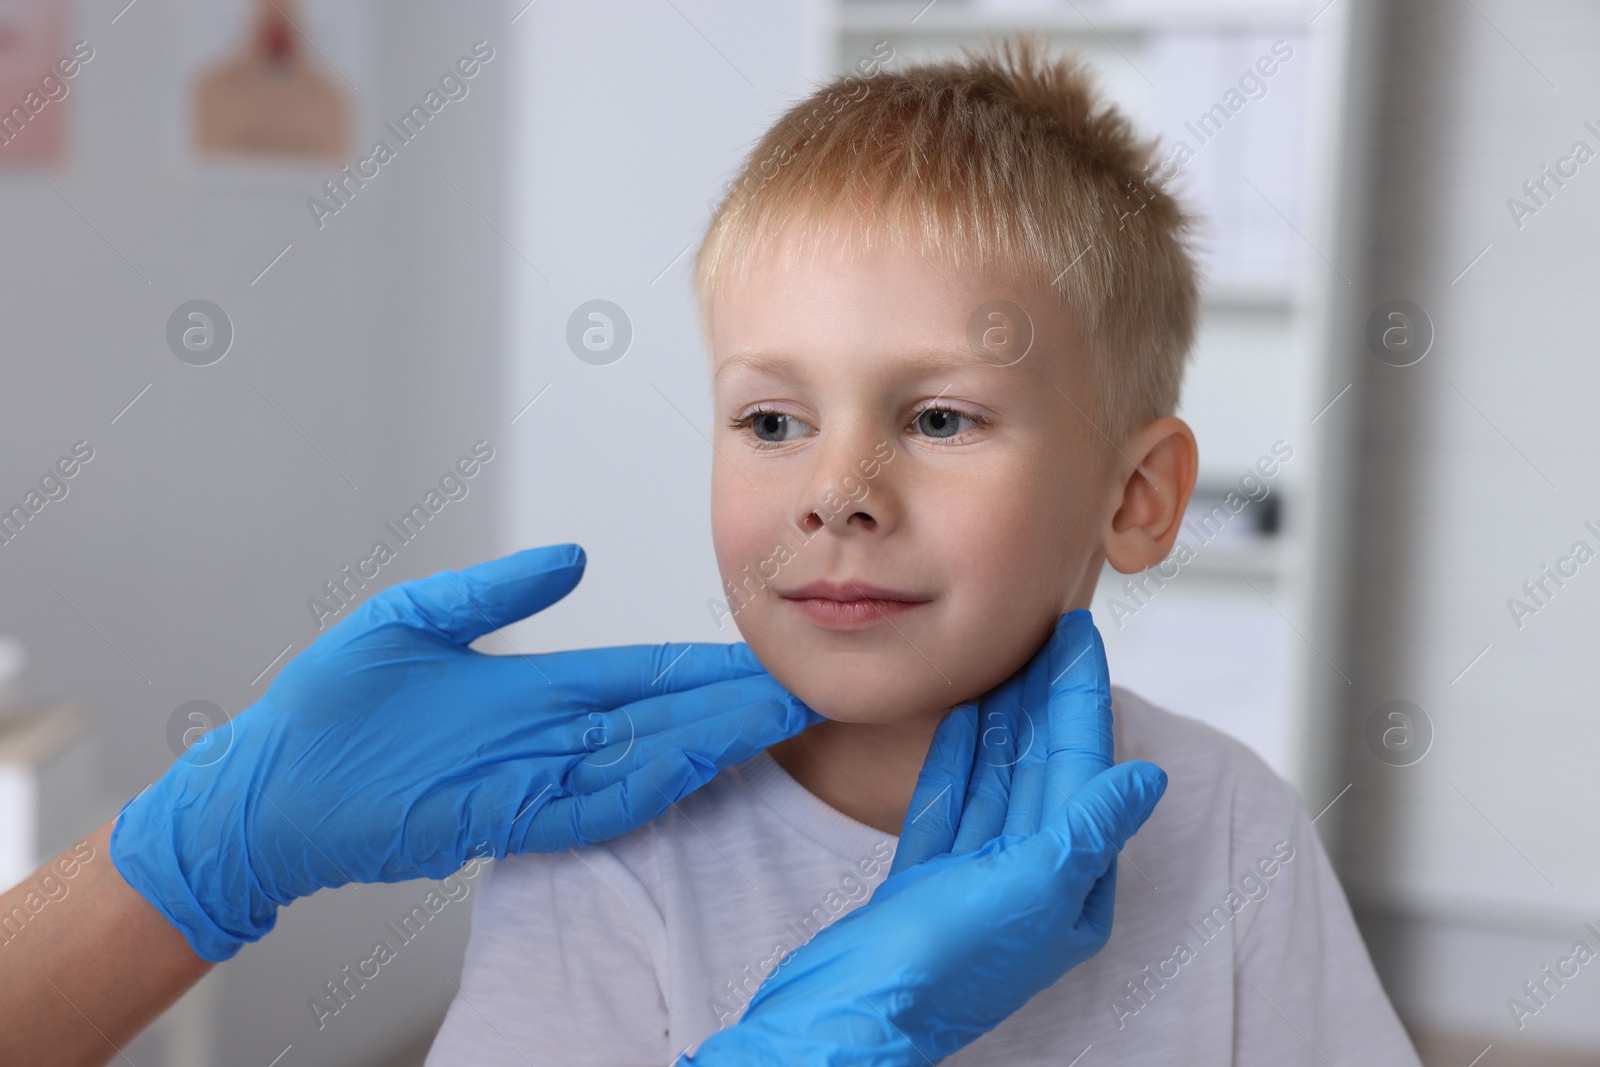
xmin=168 ymin=0 xmax=370 ymax=189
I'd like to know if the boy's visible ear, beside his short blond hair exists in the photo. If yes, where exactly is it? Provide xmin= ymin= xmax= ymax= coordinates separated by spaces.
xmin=1101 ymin=416 xmax=1200 ymax=574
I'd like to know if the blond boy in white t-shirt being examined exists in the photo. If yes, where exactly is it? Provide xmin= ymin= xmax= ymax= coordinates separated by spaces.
xmin=429 ymin=38 xmax=1416 ymax=1065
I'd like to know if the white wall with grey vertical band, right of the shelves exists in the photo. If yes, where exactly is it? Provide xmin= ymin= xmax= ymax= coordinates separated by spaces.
xmin=1344 ymin=0 xmax=1600 ymax=1062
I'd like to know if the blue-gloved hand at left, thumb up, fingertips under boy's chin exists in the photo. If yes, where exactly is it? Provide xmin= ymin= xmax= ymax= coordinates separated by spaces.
xmin=110 ymin=545 xmax=819 ymax=960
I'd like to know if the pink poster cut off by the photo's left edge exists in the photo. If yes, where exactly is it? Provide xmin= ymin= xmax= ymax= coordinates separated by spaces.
xmin=0 ymin=0 xmax=73 ymax=166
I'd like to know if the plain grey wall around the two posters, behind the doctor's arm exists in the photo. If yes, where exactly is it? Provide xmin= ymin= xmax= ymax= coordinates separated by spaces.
xmin=0 ymin=0 xmax=505 ymax=1065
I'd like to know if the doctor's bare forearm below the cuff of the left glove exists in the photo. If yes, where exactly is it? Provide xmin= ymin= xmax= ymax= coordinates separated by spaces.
xmin=0 ymin=822 xmax=213 ymax=1067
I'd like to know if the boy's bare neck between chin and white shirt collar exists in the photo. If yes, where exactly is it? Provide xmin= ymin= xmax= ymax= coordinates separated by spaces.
xmin=768 ymin=710 xmax=944 ymax=833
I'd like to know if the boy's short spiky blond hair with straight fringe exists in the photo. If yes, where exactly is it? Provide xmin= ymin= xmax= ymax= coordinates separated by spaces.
xmin=694 ymin=34 xmax=1198 ymax=434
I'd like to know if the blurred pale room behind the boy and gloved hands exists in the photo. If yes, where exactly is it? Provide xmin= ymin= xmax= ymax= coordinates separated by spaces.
xmin=0 ymin=0 xmax=1600 ymax=1067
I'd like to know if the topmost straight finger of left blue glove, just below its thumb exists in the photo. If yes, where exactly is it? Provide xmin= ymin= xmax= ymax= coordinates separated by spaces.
xmin=539 ymin=641 xmax=766 ymax=710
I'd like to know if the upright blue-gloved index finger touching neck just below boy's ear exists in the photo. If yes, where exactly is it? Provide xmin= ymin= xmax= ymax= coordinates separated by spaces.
xmin=1043 ymin=608 xmax=1115 ymax=825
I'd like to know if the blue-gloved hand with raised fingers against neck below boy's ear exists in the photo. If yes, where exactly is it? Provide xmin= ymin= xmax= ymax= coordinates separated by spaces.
xmin=683 ymin=611 xmax=1166 ymax=1067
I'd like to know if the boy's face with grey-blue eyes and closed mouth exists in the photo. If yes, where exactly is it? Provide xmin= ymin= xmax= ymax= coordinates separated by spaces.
xmin=710 ymin=219 xmax=1110 ymax=723
